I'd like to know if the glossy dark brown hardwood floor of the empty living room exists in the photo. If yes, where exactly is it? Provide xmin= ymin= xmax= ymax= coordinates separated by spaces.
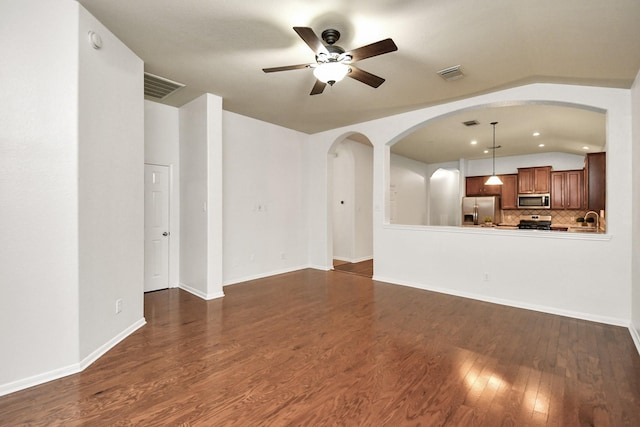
xmin=0 ymin=270 xmax=640 ymax=426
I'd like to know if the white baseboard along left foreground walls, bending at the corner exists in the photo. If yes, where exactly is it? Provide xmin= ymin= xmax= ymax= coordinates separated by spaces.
xmin=0 ymin=318 xmax=147 ymax=396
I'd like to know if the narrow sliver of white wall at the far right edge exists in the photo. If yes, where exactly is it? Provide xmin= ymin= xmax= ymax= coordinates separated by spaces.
xmin=630 ymin=72 xmax=640 ymax=352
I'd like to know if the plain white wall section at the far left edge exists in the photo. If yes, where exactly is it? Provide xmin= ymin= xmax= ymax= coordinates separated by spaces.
xmin=0 ymin=0 xmax=79 ymax=394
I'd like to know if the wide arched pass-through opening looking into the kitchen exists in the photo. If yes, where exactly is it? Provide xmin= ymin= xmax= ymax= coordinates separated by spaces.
xmin=385 ymin=101 xmax=607 ymax=230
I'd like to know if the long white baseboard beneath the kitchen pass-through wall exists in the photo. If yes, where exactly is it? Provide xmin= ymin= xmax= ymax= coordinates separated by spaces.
xmin=373 ymin=276 xmax=629 ymax=327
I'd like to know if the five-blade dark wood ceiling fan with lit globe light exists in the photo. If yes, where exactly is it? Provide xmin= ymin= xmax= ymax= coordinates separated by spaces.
xmin=262 ymin=27 xmax=398 ymax=95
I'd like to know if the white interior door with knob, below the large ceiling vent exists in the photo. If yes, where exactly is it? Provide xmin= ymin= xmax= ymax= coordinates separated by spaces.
xmin=144 ymin=165 xmax=169 ymax=292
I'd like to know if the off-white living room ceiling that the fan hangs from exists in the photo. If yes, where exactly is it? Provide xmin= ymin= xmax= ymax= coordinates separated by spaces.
xmin=78 ymin=0 xmax=640 ymax=158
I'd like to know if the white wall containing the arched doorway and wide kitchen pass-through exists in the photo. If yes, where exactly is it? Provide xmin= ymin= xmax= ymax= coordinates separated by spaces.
xmin=309 ymin=84 xmax=632 ymax=326
